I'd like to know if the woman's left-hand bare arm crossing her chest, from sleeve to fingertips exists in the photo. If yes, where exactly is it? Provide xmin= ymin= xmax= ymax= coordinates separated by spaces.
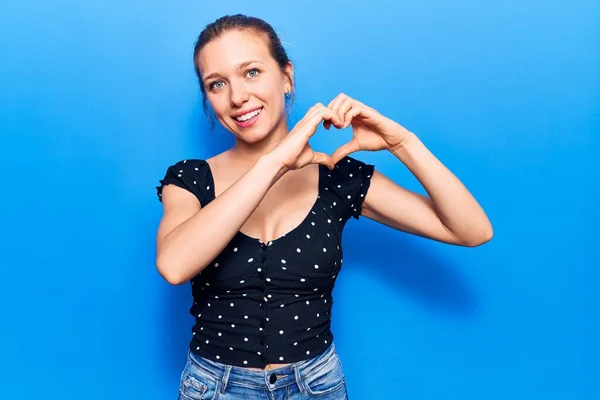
xmin=156 ymin=103 xmax=343 ymax=284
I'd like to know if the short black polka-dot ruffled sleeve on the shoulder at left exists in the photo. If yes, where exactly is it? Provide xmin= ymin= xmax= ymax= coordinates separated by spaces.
xmin=156 ymin=160 xmax=210 ymax=206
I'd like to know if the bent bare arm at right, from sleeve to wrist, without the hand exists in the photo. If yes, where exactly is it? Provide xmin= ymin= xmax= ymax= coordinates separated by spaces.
xmin=362 ymin=134 xmax=493 ymax=247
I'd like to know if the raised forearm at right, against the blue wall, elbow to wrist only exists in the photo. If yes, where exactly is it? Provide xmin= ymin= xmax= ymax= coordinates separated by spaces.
xmin=390 ymin=133 xmax=493 ymax=243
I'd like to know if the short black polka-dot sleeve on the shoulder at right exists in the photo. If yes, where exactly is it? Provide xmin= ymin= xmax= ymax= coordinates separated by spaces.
xmin=327 ymin=156 xmax=375 ymax=219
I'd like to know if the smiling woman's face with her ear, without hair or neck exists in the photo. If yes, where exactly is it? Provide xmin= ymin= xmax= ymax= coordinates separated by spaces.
xmin=196 ymin=31 xmax=293 ymax=143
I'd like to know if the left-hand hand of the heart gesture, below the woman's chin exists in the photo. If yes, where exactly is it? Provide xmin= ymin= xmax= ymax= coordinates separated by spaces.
xmin=269 ymin=103 xmax=344 ymax=170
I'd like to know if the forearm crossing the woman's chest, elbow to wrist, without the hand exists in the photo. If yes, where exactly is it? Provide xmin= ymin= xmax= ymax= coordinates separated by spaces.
xmin=157 ymin=157 xmax=285 ymax=284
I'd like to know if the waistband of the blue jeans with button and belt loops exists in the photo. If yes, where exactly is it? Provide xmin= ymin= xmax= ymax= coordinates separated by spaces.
xmin=188 ymin=342 xmax=337 ymax=390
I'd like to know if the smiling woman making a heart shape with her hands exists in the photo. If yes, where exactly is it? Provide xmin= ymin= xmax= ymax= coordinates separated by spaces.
xmin=157 ymin=15 xmax=492 ymax=399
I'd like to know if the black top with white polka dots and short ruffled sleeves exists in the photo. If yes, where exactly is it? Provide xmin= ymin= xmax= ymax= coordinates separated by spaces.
xmin=156 ymin=156 xmax=374 ymax=368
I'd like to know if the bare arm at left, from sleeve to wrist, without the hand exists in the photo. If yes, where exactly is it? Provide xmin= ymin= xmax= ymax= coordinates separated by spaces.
xmin=156 ymin=157 xmax=286 ymax=285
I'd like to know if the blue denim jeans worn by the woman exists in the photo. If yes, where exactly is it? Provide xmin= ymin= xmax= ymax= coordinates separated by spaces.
xmin=178 ymin=343 xmax=348 ymax=400
